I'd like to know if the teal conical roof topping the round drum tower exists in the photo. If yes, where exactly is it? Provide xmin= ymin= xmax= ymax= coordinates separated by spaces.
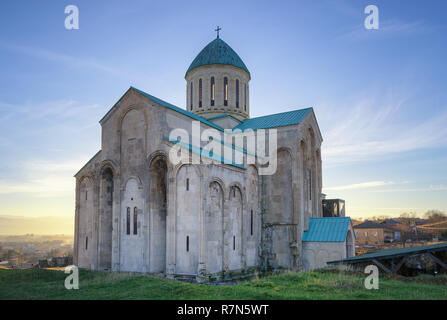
xmin=186 ymin=38 xmax=250 ymax=75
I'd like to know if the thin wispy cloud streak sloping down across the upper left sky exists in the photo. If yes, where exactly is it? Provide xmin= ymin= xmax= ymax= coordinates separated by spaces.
xmin=0 ymin=43 xmax=122 ymax=75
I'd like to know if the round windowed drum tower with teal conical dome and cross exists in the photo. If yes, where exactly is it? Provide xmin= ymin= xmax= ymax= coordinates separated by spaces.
xmin=185 ymin=28 xmax=250 ymax=120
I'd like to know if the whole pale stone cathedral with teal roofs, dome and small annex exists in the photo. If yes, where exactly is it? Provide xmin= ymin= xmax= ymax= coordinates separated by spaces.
xmin=74 ymin=35 xmax=354 ymax=282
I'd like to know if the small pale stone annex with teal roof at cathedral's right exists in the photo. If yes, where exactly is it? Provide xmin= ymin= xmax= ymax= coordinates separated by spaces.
xmin=302 ymin=217 xmax=355 ymax=270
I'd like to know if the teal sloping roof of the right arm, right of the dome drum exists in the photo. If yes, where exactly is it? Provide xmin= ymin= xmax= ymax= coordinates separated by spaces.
xmin=233 ymin=108 xmax=312 ymax=130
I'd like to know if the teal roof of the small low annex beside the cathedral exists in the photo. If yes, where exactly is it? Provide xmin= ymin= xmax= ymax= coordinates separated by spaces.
xmin=302 ymin=217 xmax=351 ymax=242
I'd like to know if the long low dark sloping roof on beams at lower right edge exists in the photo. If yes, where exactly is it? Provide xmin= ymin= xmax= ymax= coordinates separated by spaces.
xmin=331 ymin=242 xmax=447 ymax=263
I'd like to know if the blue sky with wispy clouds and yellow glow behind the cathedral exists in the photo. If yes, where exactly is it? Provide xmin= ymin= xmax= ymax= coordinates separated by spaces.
xmin=0 ymin=0 xmax=447 ymax=233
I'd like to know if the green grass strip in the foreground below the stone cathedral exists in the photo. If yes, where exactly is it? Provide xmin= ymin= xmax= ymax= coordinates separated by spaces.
xmin=0 ymin=269 xmax=447 ymax=300
